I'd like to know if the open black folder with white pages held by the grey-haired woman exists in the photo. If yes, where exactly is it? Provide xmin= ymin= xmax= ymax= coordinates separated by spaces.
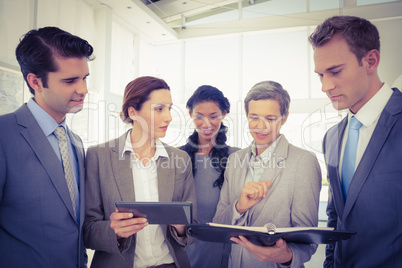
xmin=187 ymin=223 xmax=355 ymax=246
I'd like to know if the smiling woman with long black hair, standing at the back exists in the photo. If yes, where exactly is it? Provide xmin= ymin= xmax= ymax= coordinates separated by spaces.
xmin=180 ymin=85 xmax=238 ymax=268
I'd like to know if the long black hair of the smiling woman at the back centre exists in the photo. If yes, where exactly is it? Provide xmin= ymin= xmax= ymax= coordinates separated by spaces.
xmin=181 ymin=85 xmax=230 ymax=188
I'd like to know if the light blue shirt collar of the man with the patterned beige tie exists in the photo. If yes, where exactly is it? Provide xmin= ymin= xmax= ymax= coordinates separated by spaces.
xmin=27 ymin=98 xmax=67 ymax=136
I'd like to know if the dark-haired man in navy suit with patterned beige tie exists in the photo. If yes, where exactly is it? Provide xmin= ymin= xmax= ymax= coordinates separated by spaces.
xmin=0 ymin=27 xmax=93 ymax=268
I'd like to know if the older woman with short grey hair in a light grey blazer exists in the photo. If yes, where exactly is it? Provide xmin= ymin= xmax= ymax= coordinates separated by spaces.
xmin=213 ymin=81 xmax=321 ymax=268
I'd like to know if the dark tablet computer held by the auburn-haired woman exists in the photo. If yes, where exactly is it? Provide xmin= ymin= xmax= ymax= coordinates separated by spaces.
xmin=116 ymin=202 xmax=193 ymax=224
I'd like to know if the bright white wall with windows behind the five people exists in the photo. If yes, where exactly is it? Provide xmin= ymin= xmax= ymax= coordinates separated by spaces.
xmin=0 ymin=0 xmax=402 ymax=151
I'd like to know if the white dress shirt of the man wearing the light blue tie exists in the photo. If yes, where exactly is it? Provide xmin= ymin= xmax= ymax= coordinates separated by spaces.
xmin=339 ymin=83 xmax=393 ymax=178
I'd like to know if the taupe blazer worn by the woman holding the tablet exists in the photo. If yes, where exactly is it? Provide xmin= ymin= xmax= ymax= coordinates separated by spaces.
xmin=83 ymin=132 xmax=197 ymax=268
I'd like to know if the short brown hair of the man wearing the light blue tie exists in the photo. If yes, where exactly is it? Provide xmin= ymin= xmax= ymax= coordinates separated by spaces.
xmin=309 ymin=16 xmax=380 ymax=63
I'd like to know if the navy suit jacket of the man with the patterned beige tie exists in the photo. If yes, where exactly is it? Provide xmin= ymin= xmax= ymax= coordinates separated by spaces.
xmin=0 ymin=104 xmax=87 ymax=268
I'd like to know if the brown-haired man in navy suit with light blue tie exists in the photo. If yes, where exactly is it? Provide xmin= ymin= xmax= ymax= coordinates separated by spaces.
xmin=309 ymin=16 xmax=402 ymax=267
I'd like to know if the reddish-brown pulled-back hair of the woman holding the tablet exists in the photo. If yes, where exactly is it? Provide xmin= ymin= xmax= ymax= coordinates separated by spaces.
xmin=120 ymin=76 xmax=170 ymax=123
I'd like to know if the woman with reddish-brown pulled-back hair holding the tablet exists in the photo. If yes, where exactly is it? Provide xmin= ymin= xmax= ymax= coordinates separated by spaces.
xmin=83 ymin=76 xmax=197 ymax=268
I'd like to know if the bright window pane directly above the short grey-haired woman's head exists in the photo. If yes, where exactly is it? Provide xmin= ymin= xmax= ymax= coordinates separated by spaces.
xmin=242 ymin=29 xmax=311 ymax=99
